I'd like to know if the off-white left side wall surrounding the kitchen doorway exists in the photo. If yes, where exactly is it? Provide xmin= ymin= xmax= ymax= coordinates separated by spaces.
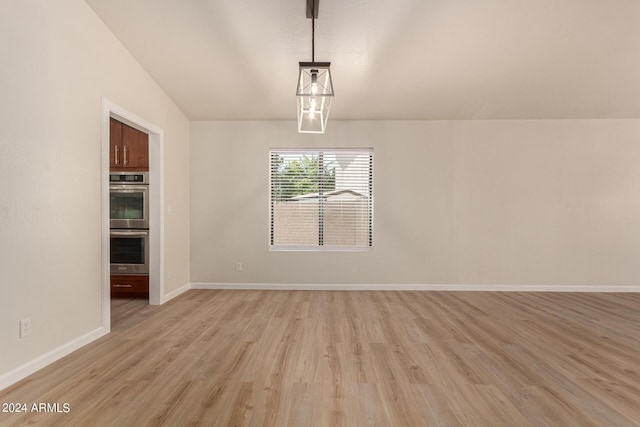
xmin=0 ymin=0 xmax=189 ymax=388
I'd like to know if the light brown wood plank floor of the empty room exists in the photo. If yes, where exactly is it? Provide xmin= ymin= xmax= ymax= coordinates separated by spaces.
xmin=0 ymin=290 xmax=640 ymax=427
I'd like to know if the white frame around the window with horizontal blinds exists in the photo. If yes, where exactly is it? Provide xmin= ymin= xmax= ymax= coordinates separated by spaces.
xmin=268 ymin=147 xmax=374 ymax=252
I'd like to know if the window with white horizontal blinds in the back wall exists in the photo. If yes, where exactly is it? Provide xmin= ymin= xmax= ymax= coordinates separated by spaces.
xmin=269 ymin=149 xmax=373 ymax=250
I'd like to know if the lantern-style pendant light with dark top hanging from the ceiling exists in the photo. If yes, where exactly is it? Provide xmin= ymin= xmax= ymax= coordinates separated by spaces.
xmin=296 ymin=0 xmax=333 ymax=133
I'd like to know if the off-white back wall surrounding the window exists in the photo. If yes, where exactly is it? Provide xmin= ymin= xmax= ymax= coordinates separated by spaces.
xmin=190 ymin=120 xmax=640 ymax=290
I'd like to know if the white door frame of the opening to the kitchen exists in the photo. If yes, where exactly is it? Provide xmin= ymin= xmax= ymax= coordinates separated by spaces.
xmin=100 ymin=97 xmax=164 ymax=330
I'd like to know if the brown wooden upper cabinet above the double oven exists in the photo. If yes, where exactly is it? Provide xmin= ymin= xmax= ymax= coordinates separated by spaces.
xmin=109 ymin=118 xmax=149 ymax=172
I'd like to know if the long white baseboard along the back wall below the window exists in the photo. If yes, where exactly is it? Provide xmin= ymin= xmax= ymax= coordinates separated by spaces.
xmin=191 ymin=283 xmax=640 ymax=292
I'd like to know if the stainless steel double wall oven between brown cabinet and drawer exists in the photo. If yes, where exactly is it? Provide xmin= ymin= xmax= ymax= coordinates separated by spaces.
xmin=109 ymin=172 xmax=149 ymax=275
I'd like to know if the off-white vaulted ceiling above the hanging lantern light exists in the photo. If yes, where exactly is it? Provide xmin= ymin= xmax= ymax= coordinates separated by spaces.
xmin=86 ymin=0 xmax=640 ymax=120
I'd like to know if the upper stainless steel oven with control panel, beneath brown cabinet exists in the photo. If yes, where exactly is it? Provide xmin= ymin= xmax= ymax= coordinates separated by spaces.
xmin=109 ymin=172 xmax=149 ymax=229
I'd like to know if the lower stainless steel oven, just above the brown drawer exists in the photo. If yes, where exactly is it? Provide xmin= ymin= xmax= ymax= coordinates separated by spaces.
xmin=111 ymin=230 xmax=149 ymax=274
